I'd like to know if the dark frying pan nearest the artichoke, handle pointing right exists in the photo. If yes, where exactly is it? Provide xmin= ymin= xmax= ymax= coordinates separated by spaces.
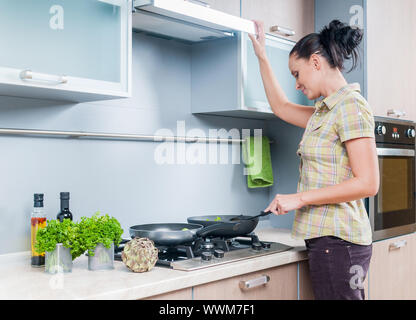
xmin=129 ymin=222 xmax=245 ymax=246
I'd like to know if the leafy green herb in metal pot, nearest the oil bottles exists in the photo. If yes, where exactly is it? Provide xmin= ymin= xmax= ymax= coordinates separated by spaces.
xmin=35 ymin=219 xmax=82 ymax=273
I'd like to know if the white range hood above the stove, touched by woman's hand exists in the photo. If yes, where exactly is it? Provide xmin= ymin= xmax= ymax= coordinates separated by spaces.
xmin=132 ymin=0 xmax=255 ymax=43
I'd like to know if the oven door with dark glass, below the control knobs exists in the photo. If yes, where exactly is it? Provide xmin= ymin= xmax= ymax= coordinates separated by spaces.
xmin=369 ymin=148 xmax=416 ymax=240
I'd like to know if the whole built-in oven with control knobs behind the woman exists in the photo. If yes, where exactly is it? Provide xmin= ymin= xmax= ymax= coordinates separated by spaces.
xmin=367 ymin=117 xmax=416 ymax=240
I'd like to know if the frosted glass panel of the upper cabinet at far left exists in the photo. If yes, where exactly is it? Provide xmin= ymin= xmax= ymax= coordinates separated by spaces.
xmin=0 ymin=0 xmax=126 ymax=82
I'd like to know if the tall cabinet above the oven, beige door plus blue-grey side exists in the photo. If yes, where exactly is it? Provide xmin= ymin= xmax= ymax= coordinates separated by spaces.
xmin=315 ymin=0 xmax=416 ymax=121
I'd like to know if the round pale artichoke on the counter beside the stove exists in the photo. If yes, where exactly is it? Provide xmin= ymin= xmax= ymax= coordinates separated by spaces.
xmin=121 ymin=238 xmax=159 ymax=272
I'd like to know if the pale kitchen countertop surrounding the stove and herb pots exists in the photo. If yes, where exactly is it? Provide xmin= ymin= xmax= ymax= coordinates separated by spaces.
xmin=0 ymin=228 xmax=307 ymax=300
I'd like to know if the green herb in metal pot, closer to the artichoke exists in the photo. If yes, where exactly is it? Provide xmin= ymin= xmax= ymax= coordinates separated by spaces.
xmin=78 ymin=211 xmax=123 ymax=270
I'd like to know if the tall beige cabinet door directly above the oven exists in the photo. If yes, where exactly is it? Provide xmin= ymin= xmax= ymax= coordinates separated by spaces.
xmin=367 ymin=0 xmax=416 ymax=120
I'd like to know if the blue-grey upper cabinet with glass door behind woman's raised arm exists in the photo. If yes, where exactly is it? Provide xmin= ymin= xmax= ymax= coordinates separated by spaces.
xmin=191 ymin=33 xmax=310 ymax=119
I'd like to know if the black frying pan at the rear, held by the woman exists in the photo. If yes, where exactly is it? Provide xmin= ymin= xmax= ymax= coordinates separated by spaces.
xmin=188 ymin=215 xmax=259 ymax=238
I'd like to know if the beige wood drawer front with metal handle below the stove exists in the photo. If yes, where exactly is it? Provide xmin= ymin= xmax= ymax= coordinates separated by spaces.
xmin=194 ymin=263 xmax=297 ymax=300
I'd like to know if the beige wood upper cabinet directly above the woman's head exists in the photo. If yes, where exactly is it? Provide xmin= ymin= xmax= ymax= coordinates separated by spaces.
xmin=241 ymin=0 xmax=314 ymax=41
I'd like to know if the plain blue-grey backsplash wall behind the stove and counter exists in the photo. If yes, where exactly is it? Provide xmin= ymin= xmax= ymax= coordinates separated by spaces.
xmin=0 ymin=34 xmax=300 ymax=254
